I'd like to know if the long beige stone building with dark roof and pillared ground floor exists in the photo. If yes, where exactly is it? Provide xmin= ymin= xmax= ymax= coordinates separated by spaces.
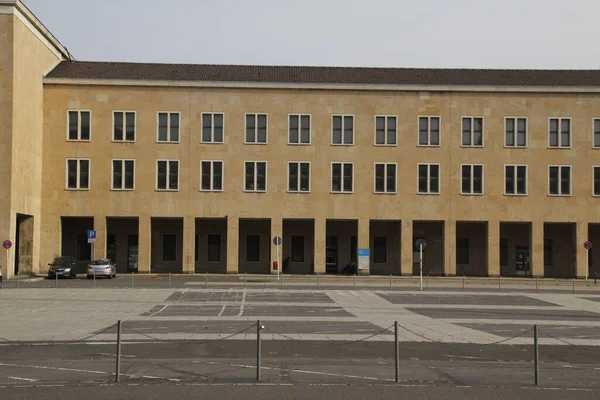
xmin=0 ymin=0 xmax=600 ymax=278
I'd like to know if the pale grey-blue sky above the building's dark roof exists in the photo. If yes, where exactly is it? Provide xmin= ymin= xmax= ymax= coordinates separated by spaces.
xmin=24 ymin=0 xmax=600 ymax=69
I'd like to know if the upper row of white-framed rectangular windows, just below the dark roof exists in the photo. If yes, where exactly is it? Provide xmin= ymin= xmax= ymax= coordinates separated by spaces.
xmin=67 ymin=111 xmax=600 ymax=148
